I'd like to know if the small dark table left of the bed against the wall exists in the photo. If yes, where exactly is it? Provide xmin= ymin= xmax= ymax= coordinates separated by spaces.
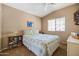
xmin=8 ymin=35 xmax=23 ymax=49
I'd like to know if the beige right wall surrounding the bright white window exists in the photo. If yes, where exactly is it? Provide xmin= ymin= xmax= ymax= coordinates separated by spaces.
xmin=42 ymin=4 xmax=79 ymax=40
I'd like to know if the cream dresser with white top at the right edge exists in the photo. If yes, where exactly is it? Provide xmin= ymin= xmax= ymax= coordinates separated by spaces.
xmin=67 ymin=36 xmax=79 ymax=56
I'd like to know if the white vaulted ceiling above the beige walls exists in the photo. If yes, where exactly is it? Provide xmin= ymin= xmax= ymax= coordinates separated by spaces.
xmin=5 ymin=3 xmax=73 ymax=17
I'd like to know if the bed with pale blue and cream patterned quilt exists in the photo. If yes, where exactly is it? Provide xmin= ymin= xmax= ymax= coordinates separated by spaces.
xmin=23 ymin=30 xmax=60 ymax=56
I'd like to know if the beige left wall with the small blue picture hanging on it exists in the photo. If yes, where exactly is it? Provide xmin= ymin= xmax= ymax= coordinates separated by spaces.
xmin=2 ymin=5 xmax=41 ymax=48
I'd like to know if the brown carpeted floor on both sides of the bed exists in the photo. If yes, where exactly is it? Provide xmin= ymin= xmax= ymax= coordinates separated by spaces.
xmin=0 ymin=46 xmax=67 ymax=56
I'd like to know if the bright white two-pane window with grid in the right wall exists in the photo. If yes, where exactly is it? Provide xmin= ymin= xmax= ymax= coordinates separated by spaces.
xmin=48 ymin=17 xmax=65 ymax=31
